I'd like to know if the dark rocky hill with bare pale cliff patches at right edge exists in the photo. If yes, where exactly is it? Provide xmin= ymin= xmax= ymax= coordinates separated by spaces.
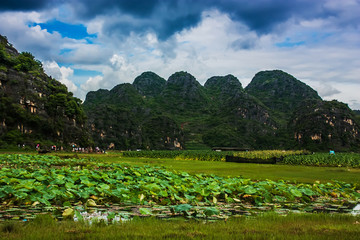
xmin=290 ymin=101 xmax=360 ymax=151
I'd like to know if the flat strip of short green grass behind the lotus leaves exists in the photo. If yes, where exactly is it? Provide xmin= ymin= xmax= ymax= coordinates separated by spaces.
xmin=71 ymin=153 xmax=360 ymax=183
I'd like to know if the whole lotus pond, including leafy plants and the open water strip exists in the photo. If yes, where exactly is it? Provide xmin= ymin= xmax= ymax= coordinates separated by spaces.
xmin=0 ymin=154 xmax=360 ymax=222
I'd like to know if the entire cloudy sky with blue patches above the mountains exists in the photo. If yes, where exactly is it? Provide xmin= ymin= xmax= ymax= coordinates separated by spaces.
xmin=0 ymin=0 xmax=360 ymax=109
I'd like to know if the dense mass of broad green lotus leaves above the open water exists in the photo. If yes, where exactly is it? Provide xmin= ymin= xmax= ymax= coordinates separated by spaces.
xmin=0 ymin=154 xmax=360 ymax=209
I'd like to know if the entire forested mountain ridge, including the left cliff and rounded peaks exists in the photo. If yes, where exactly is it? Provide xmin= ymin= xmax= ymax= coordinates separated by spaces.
xmin=0 ymin=36 xmax=360 ymax=151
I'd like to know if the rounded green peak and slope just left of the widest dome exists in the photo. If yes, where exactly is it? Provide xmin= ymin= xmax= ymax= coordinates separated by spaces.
xmin=203 ymin=75 xmax=281 ymax=148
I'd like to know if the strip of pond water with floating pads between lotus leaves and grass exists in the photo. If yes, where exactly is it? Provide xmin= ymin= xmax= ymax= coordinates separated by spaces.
xmin=0 ymin=202 xmax=360 ymax=223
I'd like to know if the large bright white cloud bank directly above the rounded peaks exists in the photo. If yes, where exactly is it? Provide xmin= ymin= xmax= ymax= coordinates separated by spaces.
xmin=73 ymin=8 xmax=360 ymax=111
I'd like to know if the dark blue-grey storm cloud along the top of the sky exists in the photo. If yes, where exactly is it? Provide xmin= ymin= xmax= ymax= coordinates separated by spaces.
xmin=0 ymin=0 xmax=351 ymax=39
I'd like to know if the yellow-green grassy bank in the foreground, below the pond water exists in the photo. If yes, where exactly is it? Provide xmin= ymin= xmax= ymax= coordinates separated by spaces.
xmin=0 ymin=213 xmax=360 ymax=240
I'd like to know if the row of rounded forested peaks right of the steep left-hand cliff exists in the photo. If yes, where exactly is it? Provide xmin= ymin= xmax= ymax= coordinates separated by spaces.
xmin=84 ymin=70 xmax=360 ymax=150
